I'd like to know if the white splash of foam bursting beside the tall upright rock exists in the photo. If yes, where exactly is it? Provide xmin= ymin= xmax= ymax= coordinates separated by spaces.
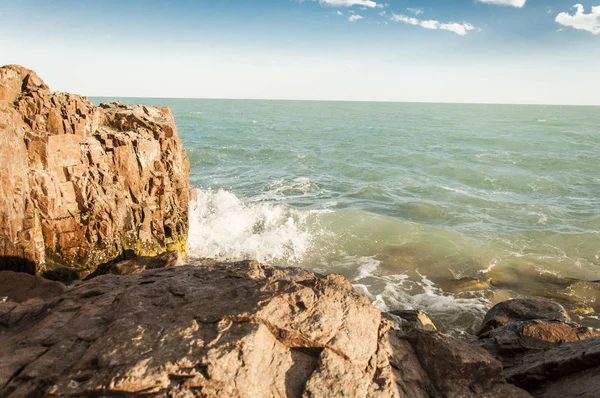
xmin=188 ymin=189 xmax=312 ymax=263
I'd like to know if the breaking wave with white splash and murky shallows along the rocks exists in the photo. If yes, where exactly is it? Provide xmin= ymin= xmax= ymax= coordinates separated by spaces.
xmin=188 ymin=188 xmax=598 ymax=333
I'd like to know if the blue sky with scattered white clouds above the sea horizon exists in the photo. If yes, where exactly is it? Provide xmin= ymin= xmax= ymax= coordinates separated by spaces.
xmin=0 ymin=0 xmax=600 ymax=105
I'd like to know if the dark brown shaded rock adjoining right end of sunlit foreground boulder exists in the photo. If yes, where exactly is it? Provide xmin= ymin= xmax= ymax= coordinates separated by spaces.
xmin=390 ymin=330 xmax=530 ymax=398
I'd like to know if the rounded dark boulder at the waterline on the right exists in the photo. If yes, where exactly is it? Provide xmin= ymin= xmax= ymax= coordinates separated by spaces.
xmin=477 ymin=299 xmax=571 ymax=336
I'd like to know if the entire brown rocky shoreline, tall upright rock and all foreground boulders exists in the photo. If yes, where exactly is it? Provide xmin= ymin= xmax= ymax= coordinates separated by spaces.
xmin=0 ymin=66 xmax=600 ymax=397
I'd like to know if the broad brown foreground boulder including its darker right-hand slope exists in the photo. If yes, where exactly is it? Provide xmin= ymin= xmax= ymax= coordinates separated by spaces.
xmin=0 ymin=262 xmax=528 ymax=398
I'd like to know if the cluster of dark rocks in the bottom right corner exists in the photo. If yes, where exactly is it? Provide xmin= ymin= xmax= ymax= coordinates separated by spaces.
xmin=477 ymin=299 xmax=600 ymax=397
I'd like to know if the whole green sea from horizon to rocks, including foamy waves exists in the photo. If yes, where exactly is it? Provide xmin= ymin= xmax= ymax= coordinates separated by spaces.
xmin=92 ymin=98 xmax=600 ymax=334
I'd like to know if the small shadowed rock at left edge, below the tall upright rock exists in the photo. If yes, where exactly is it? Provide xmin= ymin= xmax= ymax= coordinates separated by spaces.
xmin=0 ymin=271 xmax=67 ymax=303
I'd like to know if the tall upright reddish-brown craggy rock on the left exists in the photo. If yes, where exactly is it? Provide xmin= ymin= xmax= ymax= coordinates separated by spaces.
xmin=0 ymin=65 xmax=189 ymax=276
